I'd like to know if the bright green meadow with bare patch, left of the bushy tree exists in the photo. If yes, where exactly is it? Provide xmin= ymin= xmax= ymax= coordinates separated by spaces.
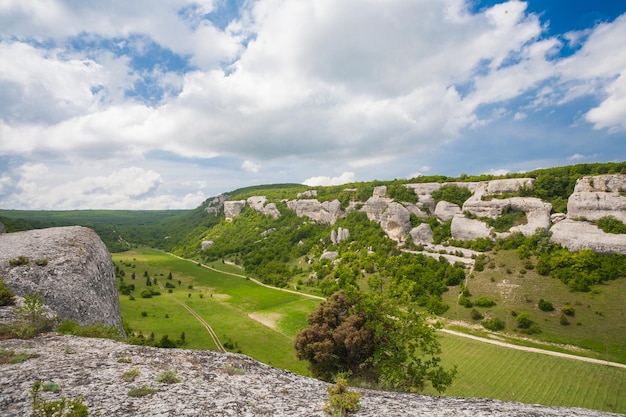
xmin=113 ymin=249 xmax=319 ymax=375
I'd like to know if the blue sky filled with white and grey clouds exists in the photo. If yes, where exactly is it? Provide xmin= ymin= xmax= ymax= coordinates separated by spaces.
xmin=0 ymin=0 xmax=626 ymax=210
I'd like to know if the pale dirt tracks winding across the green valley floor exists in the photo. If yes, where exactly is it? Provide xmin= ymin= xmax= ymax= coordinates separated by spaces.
xmin=162 ymin=253 xmax=626 ymax=369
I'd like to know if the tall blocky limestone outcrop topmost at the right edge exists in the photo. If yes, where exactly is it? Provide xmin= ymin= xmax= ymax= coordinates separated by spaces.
xmin=567 ymin=175 xmax=626 ymax=222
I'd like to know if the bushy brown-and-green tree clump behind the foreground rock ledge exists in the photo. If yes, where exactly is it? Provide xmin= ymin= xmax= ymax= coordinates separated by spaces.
xmin=295 ymin=291 xmax=456 ymax=392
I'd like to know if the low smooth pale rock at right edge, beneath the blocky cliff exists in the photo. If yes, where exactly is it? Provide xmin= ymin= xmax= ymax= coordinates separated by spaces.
xmin=550 ymin=219 xmax=626 ymax=254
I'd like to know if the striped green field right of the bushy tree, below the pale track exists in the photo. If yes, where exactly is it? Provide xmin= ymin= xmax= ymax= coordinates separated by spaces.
xmin=427 ymin=334 xmax=626 ymax=413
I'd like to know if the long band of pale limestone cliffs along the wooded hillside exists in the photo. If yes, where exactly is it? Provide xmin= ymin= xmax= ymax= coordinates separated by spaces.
xmin=216 ymin=175 xmax=626 ymax=254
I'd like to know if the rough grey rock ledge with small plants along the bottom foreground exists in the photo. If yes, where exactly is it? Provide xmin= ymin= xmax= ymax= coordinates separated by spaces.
xmin=0 ymin=335 xmax=614 ymax=417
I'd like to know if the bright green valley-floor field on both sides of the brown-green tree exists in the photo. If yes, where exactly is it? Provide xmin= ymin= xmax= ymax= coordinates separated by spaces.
xmin=113 ymin=249 xmax=626 ymax=413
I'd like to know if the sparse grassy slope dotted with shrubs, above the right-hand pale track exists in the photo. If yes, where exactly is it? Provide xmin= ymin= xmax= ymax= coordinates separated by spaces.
xmin=443 ymin=251 xmax=626 ymax=363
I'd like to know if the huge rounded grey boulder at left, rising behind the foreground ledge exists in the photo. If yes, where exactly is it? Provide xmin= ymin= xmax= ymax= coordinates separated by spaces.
xmin=0 ymin=226 xmax=123 ymax=331
